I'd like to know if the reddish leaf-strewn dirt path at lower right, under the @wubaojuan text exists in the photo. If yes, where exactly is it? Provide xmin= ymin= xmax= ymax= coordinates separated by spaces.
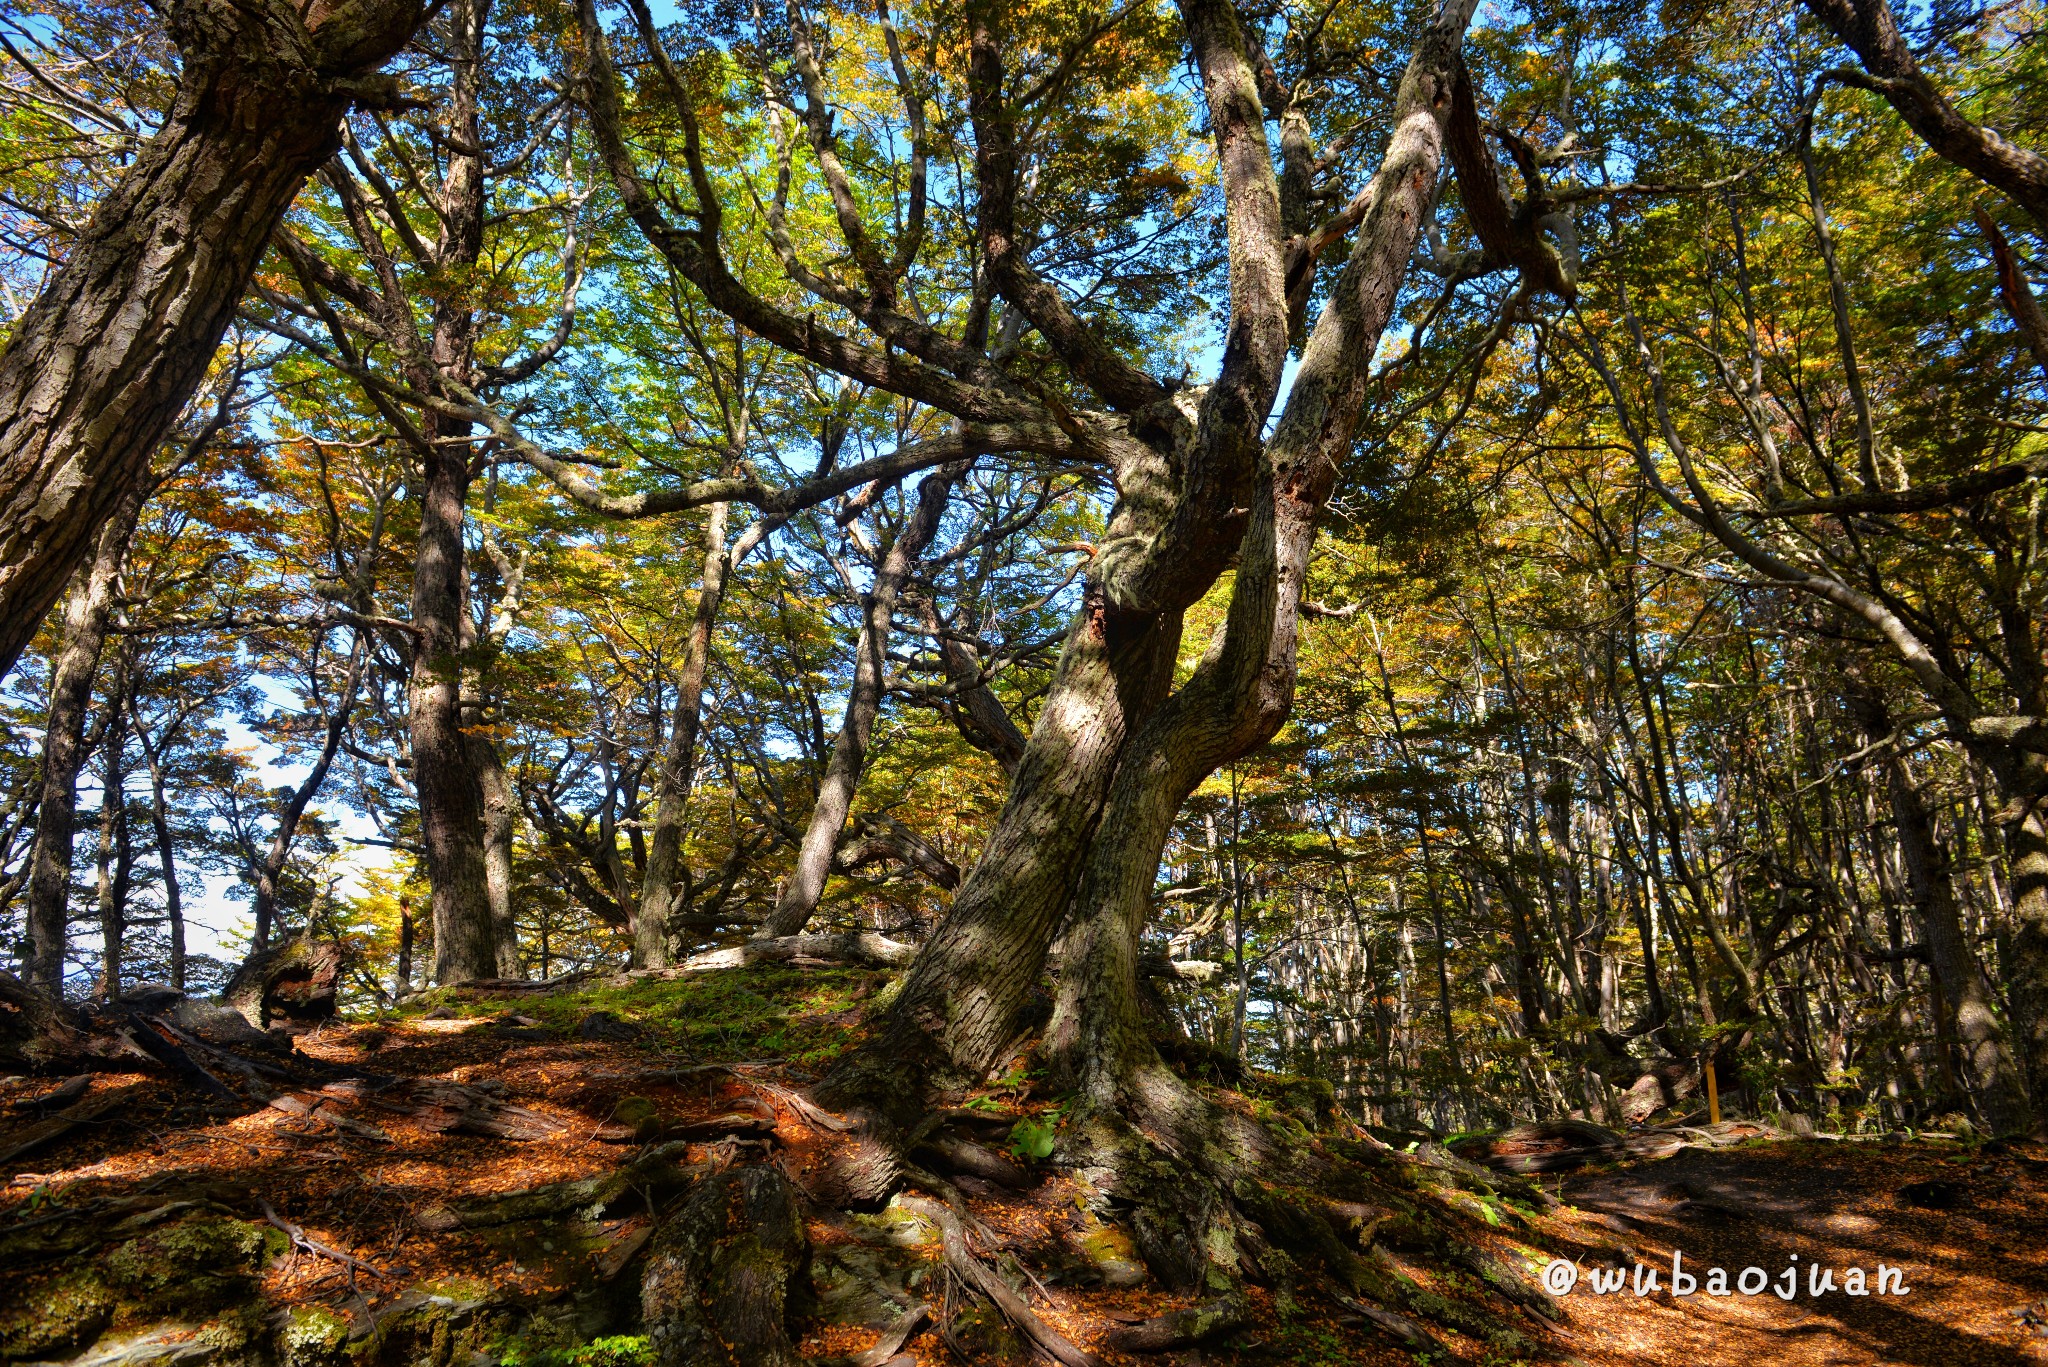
xmin=1561 ymin=1142 xmax=2048 ymax=1367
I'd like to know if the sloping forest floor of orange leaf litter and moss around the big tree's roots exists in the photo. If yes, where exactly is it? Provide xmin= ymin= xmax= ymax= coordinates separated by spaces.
xmin=0 ymin=965 xmax=2048 ymax=1367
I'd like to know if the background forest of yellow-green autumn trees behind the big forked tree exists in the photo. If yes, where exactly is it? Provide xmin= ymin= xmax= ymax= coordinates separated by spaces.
xmin=0 ymin=0 xmax=2048 ymax=1131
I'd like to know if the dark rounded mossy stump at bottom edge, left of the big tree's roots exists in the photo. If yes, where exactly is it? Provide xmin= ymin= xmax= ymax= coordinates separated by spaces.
xmin=641 ymin=1164 xmax=811 ymax=1367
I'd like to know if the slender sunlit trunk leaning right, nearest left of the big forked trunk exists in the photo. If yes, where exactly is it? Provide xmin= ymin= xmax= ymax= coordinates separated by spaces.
xmin=760 ymin=461 xmax=967 ymax=939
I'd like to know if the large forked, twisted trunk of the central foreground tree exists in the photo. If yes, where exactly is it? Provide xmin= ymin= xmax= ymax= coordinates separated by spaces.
xmin=821 ymin=4 xmax=1470 ymax=1117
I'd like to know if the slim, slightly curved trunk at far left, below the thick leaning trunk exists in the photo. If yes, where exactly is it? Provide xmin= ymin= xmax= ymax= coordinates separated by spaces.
xmin=27 ymin=480 xmax=147 ymax=996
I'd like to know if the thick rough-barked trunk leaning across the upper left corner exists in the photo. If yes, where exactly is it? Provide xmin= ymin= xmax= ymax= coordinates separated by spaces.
xmin=0 ymin=0 xmax=420 ymax=672
